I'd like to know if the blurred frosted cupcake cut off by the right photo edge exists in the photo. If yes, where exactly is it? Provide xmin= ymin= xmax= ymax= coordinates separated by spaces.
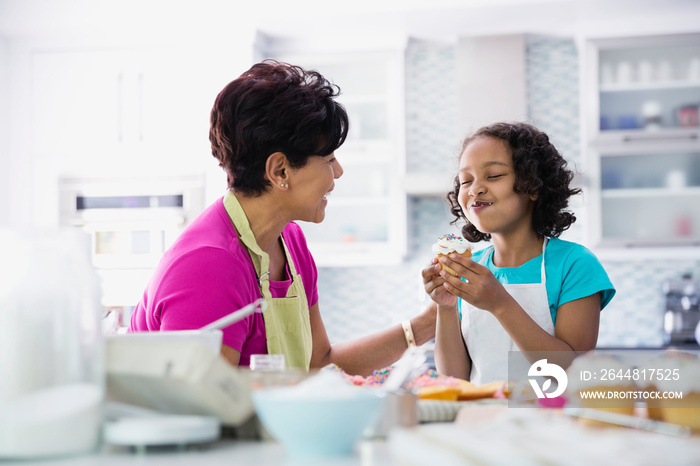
xmin=645 ymin=350 xmax=700 ymax=432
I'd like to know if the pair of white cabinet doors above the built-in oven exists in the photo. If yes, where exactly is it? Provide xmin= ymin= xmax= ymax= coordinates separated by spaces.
xmin=32 ymin=47 xmax=215 ymax=158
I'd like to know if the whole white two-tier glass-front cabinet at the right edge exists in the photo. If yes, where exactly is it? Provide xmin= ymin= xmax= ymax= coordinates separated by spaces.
xmin=582 ymin=34 xmax=700 ymax=256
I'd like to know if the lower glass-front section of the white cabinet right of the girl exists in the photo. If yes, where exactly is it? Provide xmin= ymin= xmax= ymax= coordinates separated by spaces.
xmin=596 ymin=144 xmax=700 ymax=246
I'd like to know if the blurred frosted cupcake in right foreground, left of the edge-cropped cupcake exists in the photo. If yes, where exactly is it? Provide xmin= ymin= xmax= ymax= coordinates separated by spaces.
xmin=566 ymin=351 xmax=638 ymax=425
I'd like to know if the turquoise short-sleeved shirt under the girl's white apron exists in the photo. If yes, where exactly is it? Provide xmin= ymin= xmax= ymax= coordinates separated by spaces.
xmin=458 ymin=238 xmax=615 ymax=324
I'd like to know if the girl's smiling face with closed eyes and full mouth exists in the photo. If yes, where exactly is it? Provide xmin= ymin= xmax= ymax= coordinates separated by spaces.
xmin=458 ymin=136 xmax=535 ymax=235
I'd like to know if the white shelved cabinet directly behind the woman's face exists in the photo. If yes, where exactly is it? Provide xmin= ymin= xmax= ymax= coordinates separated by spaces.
xmin=266 ymin=47 xmax=406 ymax=266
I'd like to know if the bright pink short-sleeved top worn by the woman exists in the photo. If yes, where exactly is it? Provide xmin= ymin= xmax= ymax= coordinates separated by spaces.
xmin=128 ymin=198 xmax=318 ymax=366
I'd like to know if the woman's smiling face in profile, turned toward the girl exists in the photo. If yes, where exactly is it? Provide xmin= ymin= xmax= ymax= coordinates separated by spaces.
xmin=289 ymin=153 xmax=343 ymax=223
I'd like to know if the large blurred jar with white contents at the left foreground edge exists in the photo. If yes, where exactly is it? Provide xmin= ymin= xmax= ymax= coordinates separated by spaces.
xmin=0 ymin=229 xmax=104 ymax=460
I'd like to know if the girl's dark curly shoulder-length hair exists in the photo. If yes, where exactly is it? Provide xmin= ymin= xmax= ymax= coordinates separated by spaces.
xmin=447 ymin=122 xmax=581 ymax=242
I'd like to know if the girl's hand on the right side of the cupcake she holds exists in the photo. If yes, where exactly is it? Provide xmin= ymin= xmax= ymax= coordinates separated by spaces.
xmin=436 ymin=254 xmax=513 ymax=314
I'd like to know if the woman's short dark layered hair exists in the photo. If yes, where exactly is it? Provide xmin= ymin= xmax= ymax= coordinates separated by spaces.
xmin=209 ymin=60 xmax=348 ymax=195
